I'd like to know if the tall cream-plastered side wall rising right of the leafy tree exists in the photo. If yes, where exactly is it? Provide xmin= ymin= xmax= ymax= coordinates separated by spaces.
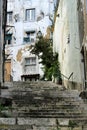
xmin=53 ymin=0 xmax=84 ymax=89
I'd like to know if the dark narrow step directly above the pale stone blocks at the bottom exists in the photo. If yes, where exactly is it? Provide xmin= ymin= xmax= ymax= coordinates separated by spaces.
xmin=12 ymin=112 xmax=87 ymax=118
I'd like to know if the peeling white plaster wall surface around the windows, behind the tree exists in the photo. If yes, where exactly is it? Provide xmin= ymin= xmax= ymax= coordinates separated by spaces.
xmin=6 ymin=0 xmax=54 ymax=81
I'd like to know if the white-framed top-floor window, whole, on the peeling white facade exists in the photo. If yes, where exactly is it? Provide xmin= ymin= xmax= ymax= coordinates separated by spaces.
xmin=25 ymin=9 xmax=35 ymax=21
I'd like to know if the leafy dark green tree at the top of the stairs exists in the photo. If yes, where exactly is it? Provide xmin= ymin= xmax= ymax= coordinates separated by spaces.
xmin=31 ymin=36 xmax=61 ymax=83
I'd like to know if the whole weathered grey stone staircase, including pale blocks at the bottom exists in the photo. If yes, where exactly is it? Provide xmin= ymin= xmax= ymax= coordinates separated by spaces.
xmin=0 ymin=81 xmax=87 ymax=130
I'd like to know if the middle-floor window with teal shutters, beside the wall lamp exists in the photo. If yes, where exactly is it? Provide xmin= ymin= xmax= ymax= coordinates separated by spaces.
xmin=23 ymin=31 xmax=35 ymax=43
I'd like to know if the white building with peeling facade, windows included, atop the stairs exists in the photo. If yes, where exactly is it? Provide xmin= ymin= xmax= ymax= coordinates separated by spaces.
xmin=5 ymin=0 xmax=54 ymax=81
